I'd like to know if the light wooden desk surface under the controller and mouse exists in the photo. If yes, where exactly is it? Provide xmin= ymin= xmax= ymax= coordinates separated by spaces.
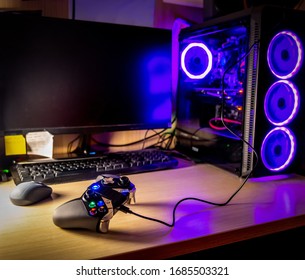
xmin=0 ymin=164 xmax=305 ymax=260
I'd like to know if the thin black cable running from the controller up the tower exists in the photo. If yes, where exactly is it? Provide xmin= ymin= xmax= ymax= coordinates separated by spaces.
xmin=119 ymin=41 xmax=259 ymax=227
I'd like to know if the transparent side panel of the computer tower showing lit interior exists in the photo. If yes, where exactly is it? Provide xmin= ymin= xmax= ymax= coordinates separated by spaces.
xmin=177 ymin=18 xmax=249 ymax=173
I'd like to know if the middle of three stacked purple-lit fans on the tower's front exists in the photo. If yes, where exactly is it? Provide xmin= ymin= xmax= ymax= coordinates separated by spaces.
xmin=264 ymin=80 xmax=300 ymax=126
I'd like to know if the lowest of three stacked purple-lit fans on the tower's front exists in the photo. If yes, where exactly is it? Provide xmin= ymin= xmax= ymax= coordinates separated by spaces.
xmin=261 ymin=127 xmax=296 ymax=171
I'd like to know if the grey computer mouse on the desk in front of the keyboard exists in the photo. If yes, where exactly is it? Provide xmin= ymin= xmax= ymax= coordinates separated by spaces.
xmin=10 ymin=181 xmax=52 ymax=206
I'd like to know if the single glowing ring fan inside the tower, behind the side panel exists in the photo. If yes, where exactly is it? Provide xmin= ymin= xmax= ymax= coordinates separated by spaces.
xmin=181 ymin=43 xmax=212 ymax=79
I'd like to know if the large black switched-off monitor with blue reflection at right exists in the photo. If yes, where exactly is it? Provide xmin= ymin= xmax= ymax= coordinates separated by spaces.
xmin=0 ymin=14 xmax=172 ymax=135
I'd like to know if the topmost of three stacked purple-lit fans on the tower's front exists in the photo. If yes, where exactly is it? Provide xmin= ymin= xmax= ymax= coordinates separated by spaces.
xmin=267 ymin=31 xmax=304 ymax=79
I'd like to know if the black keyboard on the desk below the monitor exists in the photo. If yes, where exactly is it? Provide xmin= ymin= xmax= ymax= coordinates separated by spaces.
xmin=10 ymin=149 xmax=178 ymax=185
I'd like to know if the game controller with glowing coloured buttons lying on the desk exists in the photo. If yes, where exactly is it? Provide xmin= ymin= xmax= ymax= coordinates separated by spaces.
xmin=53 ymin=174 xmax=136 ymax=233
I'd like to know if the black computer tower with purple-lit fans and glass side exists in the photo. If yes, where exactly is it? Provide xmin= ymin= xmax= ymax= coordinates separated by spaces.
xmin=176 ymin=6 xmax=305 ymax=177
